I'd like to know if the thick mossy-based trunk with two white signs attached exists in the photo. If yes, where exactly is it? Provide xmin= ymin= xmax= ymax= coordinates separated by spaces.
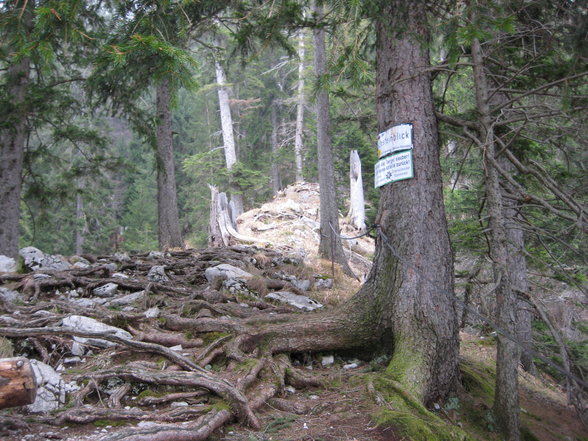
xmin=368 ymin=0 xmax=459 ymax=405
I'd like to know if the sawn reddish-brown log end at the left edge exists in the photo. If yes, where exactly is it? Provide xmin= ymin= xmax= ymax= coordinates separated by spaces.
xmin=0 ymin=357 xmax=37 ymax=409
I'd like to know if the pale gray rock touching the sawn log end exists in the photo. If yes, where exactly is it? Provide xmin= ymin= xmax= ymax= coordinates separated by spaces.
xmin=26 ymin=360 xmax=66 ymax=413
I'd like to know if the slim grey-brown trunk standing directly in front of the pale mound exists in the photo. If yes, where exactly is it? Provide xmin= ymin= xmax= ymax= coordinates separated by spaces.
xmin=313 ymin=1 xmax=353 ymax=275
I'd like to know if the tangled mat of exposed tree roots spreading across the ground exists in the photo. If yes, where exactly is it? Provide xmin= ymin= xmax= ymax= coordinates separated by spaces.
xmin=0 ymin=246 xmax=374 ymax=441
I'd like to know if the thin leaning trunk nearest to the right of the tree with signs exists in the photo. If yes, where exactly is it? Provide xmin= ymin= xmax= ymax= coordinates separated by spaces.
xmin=472 ymin=38 xmax=520 ymax=441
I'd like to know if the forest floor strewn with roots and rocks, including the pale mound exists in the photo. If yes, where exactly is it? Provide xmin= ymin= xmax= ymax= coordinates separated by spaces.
xmin=0 ymin=180 xmax=588 ymax=441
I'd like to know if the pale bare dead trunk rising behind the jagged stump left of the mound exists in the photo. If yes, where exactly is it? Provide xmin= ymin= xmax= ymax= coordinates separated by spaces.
xmin=214 ymin=60 xmax=243 ymax=218
